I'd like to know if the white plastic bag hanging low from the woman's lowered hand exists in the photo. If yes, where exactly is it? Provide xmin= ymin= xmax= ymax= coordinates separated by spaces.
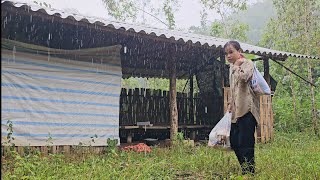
xmin=208 ymin=112 xmax=231 ymax=147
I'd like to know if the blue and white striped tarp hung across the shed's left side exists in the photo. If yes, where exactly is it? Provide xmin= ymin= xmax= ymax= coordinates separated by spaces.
xmin=1 ymin=47 xmax=122 ymax=146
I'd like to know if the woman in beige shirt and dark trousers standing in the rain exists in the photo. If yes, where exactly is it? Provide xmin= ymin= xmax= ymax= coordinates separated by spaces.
xmin=224 ymin=41 xmax=259 ymax=174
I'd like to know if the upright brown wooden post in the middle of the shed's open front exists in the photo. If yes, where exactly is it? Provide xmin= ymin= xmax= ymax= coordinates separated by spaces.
xmin=169 ymin=53 xmax=178 ymax=141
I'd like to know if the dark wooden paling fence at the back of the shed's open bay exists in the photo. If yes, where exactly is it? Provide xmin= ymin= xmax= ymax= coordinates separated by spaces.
xmin=120 ymin=88 xmax=222 ymax=126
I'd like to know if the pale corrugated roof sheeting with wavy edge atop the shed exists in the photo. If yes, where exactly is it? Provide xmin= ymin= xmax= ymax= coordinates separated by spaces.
xmin=1 ymin=0 xmax=320 ymax=59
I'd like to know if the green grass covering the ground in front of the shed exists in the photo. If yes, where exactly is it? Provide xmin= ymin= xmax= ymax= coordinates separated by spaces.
xmin=1 ymin=132 xmax=320 ymax=180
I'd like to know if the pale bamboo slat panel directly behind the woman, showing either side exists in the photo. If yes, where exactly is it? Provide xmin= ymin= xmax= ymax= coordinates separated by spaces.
xmin=224 ymin=87 xmax=274 ymax=143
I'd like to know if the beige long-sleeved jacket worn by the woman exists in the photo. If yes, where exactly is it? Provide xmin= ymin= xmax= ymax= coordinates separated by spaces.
xmin=228 ymin=59 xmax=260 ymax=124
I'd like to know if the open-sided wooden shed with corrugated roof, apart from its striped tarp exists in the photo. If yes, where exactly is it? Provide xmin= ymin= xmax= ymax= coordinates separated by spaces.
xmin=1 ymin=0 xmax=316 ymax=155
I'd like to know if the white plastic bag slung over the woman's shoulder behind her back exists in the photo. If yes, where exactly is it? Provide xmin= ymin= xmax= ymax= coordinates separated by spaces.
xmin=250 ymin=64 xmax=271 ymax=95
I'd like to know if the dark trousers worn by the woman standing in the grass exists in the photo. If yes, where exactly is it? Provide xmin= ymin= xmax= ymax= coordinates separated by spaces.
xmin=230 ymin=112 xmax=257 ymax=174
